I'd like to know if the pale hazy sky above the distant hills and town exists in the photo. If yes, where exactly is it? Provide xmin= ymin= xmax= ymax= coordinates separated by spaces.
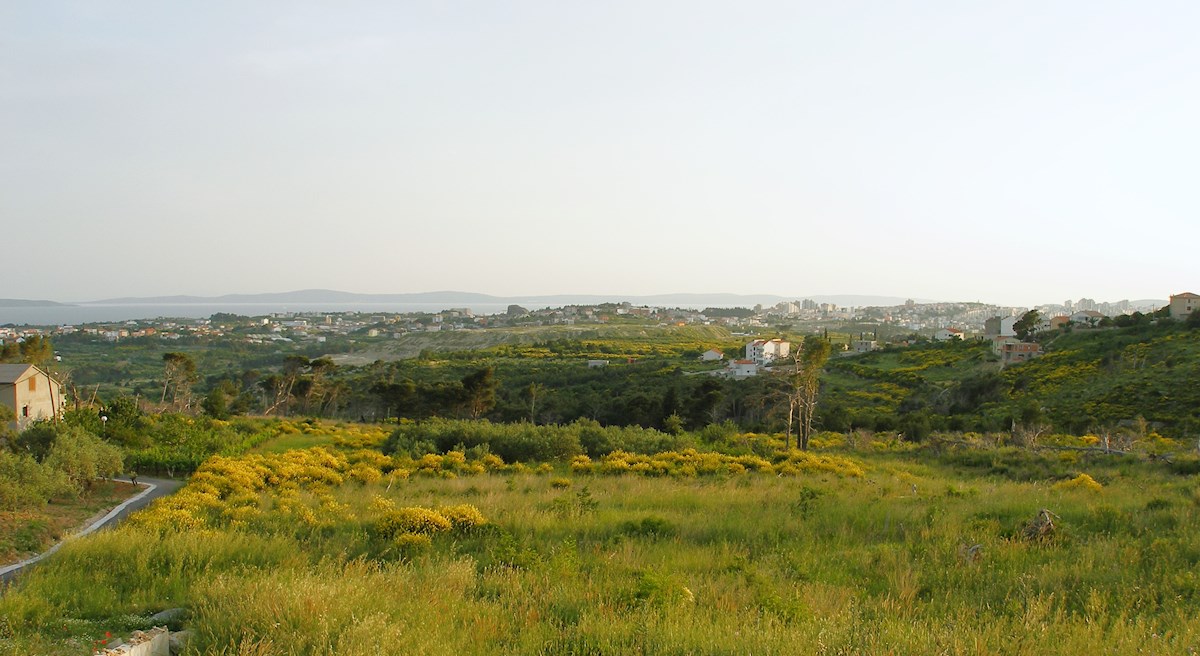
xmin=0 ymin=0 xmax=1200 ymax=305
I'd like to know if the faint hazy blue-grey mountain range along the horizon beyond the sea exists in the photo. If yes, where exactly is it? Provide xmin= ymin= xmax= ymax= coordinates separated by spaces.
xmin=79 ymin=289 xmax=905 ymax=307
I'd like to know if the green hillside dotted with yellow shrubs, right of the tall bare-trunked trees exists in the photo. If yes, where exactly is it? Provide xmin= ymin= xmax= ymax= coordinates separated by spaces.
xmin=824 ymin=321 xmax=1200 ymax=437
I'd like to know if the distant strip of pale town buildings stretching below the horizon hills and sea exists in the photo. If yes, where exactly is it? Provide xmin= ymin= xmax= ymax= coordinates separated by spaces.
xmin=0 ymin=293 xmax=1198 ymax=363
